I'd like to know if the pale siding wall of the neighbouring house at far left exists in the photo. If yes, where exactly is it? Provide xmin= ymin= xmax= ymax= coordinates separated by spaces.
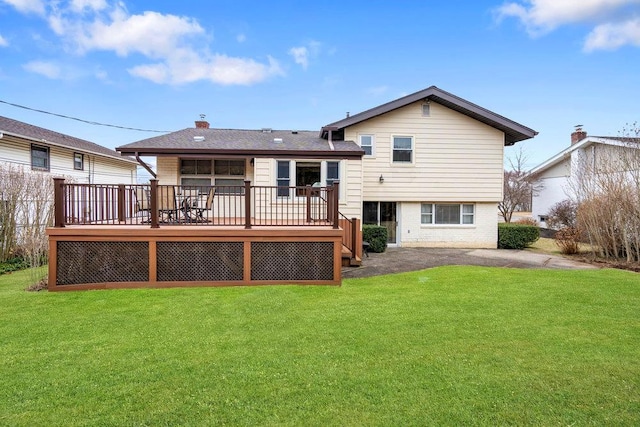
xmin=0 ymin=134 xmax=137 ymax=184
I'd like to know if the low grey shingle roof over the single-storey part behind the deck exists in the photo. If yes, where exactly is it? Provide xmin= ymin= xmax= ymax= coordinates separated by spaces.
xmin=116 ymin=128 xmax=364 ymax=158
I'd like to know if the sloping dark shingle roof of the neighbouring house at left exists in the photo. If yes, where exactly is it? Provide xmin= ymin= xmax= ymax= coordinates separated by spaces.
xmin=0 ymin=116 xmax=137 ymax=164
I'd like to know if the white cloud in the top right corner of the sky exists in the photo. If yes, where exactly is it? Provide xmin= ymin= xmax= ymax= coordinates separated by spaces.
xmin=494 ymin=0 xmax=640 ymax=51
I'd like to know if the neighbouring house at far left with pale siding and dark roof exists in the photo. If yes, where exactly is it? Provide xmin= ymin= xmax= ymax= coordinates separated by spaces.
xmin=0 ymin=116 xmax=138 ymax=184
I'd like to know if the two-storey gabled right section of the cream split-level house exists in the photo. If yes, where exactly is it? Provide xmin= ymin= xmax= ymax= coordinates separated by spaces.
xmin=325 ymin=87 xmax=536 ymax=248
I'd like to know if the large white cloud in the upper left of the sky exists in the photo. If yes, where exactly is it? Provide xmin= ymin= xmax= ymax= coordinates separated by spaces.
xmin=7 ymin=0 xmax=283 ymax=85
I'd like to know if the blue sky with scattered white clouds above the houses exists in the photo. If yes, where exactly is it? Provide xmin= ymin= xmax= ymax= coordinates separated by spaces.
xmin=0 ymin=0 xmax=640 ymax=167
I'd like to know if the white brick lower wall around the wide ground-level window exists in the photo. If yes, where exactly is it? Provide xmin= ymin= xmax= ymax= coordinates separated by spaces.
xmin=398 ymin=201 xmax=498 ymax=248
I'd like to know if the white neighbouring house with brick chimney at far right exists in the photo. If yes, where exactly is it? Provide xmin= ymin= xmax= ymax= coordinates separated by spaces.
xmin=529 ymin=127 xmax=640 ymax=226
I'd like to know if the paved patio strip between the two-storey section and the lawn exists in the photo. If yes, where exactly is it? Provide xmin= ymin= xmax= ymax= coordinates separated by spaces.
xmin=342 ymin=248 xmax=598 ymax=278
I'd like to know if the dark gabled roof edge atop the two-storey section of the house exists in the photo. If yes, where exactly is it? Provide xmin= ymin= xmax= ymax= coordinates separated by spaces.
xmin=320 ymin=86 xmax=538 ymax=145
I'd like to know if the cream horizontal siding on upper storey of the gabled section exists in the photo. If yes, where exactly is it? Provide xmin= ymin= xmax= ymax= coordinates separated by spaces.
xmin=345 ymin=102 xmax=504 ymax=202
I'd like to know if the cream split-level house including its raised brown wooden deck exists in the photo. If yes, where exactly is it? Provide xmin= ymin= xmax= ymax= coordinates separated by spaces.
xmin=48 ymin=86 xmax=536 ymax=290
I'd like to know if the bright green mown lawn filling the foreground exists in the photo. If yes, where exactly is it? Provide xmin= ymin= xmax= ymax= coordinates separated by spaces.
xmin=0 ymin=267 xmax=640 ymax=426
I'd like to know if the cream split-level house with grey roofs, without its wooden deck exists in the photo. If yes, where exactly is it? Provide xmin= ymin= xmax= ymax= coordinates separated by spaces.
xmin=117 ymin=86 xmax=537 ymax=248
